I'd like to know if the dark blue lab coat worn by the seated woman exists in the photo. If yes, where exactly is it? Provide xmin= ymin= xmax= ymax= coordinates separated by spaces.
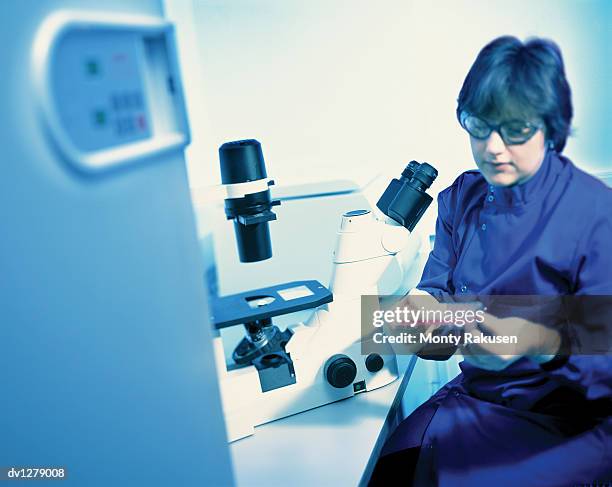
xmin=372 ymin=150 xmax=612 ymax=487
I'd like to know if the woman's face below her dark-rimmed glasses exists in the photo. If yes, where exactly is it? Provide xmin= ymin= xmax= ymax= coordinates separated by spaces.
xmin=470 ymin=129 xmax=546 ymax=186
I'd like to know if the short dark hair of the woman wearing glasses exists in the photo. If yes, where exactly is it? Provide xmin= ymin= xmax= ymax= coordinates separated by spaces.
xmin=457 ymin=36 xmax=573 ymax=153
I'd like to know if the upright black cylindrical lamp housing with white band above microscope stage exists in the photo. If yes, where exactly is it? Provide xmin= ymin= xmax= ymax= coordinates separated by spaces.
xmin=219 ymin=139 xmax=280 ymax=262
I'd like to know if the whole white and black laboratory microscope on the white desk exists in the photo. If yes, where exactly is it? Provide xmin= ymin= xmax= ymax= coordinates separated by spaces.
xmin=212 ymin=140 xmax=438 ymax=442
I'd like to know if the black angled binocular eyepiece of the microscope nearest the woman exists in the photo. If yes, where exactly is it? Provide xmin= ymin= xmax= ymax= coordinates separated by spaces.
xmin=376 ymin=161 xmax=438 ymax=231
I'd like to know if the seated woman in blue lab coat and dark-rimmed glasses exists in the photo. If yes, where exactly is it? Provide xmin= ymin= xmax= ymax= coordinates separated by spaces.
xmin=370 ymin=36 xmax=612 ymax=487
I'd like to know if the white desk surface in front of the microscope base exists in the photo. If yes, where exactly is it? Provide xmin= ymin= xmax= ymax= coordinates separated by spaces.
xmin=230 ymin=357 xmax=416 ymax=487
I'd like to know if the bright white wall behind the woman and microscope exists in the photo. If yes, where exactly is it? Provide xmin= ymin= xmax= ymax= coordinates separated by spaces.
xmin=165 ymin=0 xmax=612 ymax=196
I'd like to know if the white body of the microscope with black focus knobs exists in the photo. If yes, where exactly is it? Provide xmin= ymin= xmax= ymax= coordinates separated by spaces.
xmin=214 ymin=210 xmax=420 ymax=441
